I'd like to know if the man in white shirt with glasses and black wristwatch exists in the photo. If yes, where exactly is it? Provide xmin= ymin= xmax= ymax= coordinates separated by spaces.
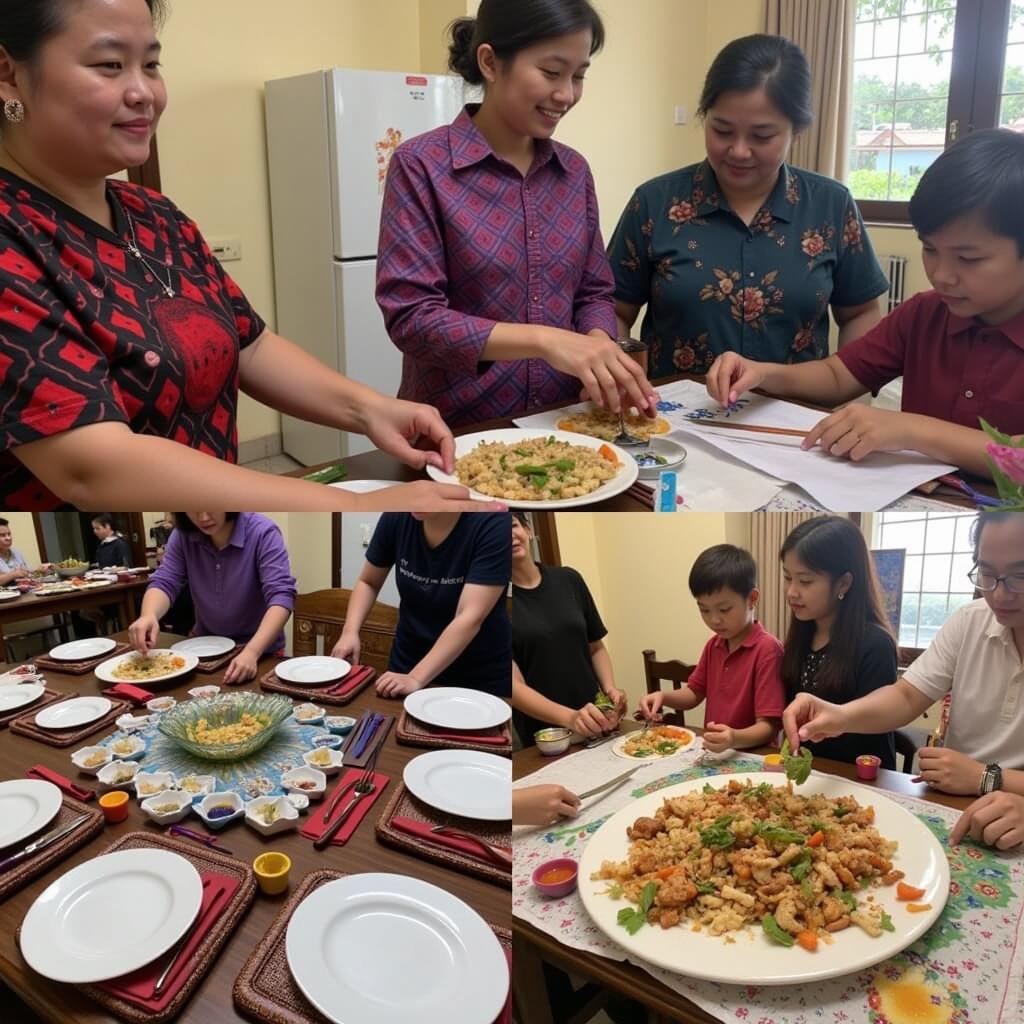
xmin=782 ymin=512 xmax=1024 ymax=849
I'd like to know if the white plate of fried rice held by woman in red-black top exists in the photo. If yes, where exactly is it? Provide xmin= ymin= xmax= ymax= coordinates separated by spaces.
xmin=427 ymin=427 xmax=638 ymax=509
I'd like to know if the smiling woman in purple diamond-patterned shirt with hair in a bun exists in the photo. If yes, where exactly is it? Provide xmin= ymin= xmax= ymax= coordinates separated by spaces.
xmin=377 ymin=0 xmax=656 ymax=426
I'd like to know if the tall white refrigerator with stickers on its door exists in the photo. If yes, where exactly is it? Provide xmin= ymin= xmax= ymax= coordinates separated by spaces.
xmin=266 ymin=69 xmax=464 ymax=466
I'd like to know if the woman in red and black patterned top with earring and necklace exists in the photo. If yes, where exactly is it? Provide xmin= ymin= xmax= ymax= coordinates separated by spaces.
xmin=0 ymin=0 xmax=495 ymax=510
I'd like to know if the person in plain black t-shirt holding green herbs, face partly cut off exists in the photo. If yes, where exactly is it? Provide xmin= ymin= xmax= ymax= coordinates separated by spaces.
xmin=512 ymin=513 xmax=626 ymax=745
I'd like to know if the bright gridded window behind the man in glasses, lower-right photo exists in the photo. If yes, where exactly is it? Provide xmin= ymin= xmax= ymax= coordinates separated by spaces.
xmin=871 ymin=512 xmax=977 ymax=650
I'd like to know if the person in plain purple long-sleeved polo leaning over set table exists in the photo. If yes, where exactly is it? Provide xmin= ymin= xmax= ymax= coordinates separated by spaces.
xmin=128 ymin=512 xmax=295 ymax=683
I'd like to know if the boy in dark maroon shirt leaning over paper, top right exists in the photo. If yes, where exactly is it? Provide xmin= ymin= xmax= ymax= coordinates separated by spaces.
xmin=708 ymin=128 xmax=1024 ymax=478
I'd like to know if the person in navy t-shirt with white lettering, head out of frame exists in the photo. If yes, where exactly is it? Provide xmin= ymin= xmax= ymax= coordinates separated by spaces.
xmin=332 ymin=512 xmax=512 ymax=698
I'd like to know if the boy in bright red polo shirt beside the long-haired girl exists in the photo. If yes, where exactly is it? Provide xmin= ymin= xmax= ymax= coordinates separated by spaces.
xmin=640 ymin=544 xmax=785 ymax=754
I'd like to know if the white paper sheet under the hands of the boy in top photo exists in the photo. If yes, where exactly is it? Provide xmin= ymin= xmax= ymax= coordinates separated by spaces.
xmin=658 ymin=381 xmax=956 ymax=512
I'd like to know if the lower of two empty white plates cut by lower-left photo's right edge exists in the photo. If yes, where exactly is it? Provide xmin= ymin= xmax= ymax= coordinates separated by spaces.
xmin=401 ymin=751 xmax=512 ymax=821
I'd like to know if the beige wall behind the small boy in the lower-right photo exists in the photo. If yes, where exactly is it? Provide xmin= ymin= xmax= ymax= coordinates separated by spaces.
xmin=555 ymin=512 xmax=750 ymax=723
